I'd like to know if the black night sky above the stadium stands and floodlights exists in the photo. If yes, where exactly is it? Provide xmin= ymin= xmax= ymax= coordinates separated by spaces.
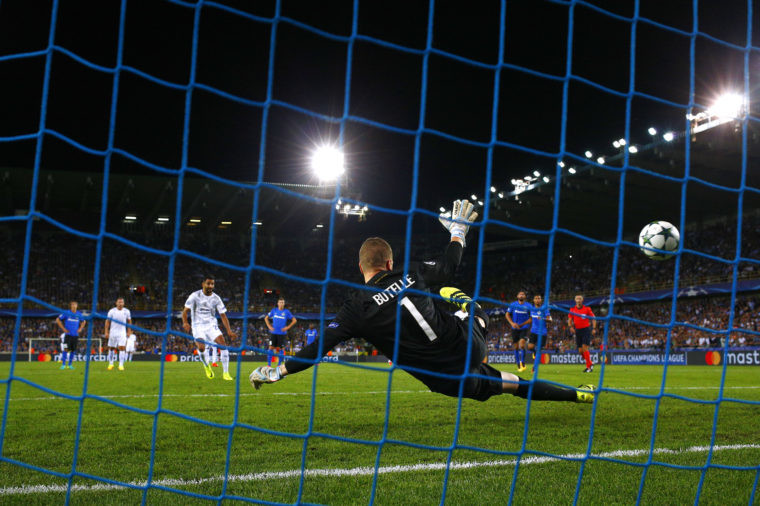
xmin=0 ymin=0 xmax=760 ymax=241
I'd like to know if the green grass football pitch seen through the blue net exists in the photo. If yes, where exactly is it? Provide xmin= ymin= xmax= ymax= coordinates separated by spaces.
xmin=0 ymin=362 xmax=760 ymax=505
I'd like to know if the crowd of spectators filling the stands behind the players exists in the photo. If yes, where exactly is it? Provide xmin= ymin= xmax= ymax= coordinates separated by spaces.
xmin=0 ymin=213 xmax=760 ymax=352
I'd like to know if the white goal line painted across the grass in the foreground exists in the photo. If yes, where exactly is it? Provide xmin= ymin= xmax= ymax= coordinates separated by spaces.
xmin=0 ymin=444 xmax=760 ymax=497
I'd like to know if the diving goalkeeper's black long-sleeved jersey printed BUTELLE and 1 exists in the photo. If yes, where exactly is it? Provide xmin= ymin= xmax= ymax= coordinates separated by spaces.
xmin=285 ymin=242 xmax=480 ymax=375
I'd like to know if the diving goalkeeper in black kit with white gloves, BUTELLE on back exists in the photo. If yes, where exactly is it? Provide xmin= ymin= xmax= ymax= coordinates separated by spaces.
xmin=250 ymin=200 xmax=595 ymax=403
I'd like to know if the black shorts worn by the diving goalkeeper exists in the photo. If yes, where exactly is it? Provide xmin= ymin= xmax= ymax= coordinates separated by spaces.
xmin=409 ymin=310 xmax=502 ymax=401
